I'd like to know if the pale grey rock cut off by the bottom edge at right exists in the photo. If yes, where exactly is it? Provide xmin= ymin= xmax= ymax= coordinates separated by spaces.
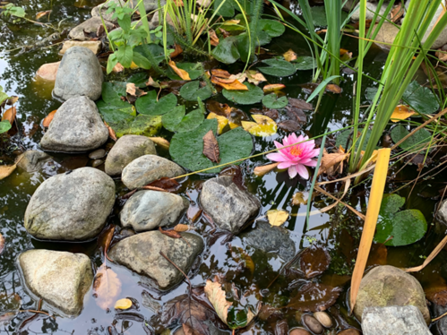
xmin=362 ymin=305 xmax=431 ymax=335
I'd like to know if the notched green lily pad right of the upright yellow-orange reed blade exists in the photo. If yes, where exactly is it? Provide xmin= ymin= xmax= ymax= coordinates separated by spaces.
xmin=374 ymin=194 xmax=427 ymax=247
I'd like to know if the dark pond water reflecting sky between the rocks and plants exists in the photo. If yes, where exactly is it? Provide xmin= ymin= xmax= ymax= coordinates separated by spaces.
xmin=0 ymin=0 xmax=447 ymax=334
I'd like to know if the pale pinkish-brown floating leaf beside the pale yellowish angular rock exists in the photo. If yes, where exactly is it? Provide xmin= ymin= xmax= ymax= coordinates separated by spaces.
xmin=93 ymin=264 xmax=121 ymax=310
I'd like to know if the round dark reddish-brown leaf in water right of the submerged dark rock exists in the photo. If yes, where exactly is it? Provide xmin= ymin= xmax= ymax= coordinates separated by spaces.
xmin=300 ymin=245 xmax=331 ymax=279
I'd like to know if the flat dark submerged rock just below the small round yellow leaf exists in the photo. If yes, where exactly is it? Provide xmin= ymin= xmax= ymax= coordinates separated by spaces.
xmin=241 ymin=221 xmax=295 ymax=262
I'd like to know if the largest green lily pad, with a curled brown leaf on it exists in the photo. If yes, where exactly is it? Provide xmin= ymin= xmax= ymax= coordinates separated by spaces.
xmin=169 ymin=119 xmax=253 ymax=173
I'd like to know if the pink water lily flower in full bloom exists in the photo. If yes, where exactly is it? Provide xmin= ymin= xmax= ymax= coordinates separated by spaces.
xmin=267 ymin=133 xmax=320 ymax=179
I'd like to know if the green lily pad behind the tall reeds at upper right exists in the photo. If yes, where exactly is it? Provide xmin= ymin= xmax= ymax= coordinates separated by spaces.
xmin=402 ymin=81 xmax=439 ymax=114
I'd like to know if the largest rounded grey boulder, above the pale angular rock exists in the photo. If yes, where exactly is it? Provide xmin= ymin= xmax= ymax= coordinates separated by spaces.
xmin=25 ymin=167 xmax=115 ymax=241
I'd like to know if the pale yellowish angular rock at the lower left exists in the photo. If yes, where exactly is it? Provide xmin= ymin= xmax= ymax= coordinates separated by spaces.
xmin=18 ymin=250 xmax=93 ymax=315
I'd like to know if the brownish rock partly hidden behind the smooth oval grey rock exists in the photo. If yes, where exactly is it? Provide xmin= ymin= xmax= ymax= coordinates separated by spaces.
xmin=105 ymin=135 xmax=157 ymax=176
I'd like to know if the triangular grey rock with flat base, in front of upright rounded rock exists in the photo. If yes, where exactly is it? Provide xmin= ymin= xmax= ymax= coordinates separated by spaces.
xmin=40 ymin=96 xmax=109 ymax=152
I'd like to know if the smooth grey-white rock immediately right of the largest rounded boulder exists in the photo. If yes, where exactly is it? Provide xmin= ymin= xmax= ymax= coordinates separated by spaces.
xmin=120 ymin=191 xmax=189 ymax=232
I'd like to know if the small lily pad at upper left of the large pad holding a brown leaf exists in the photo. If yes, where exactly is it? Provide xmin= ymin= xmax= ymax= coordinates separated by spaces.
xmin=162 ymin=106 xmax=205 ymax=133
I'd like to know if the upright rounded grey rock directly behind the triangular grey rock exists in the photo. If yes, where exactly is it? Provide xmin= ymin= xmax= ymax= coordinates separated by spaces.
xmin=53 ymin=47 xmax=104 ymax=100
